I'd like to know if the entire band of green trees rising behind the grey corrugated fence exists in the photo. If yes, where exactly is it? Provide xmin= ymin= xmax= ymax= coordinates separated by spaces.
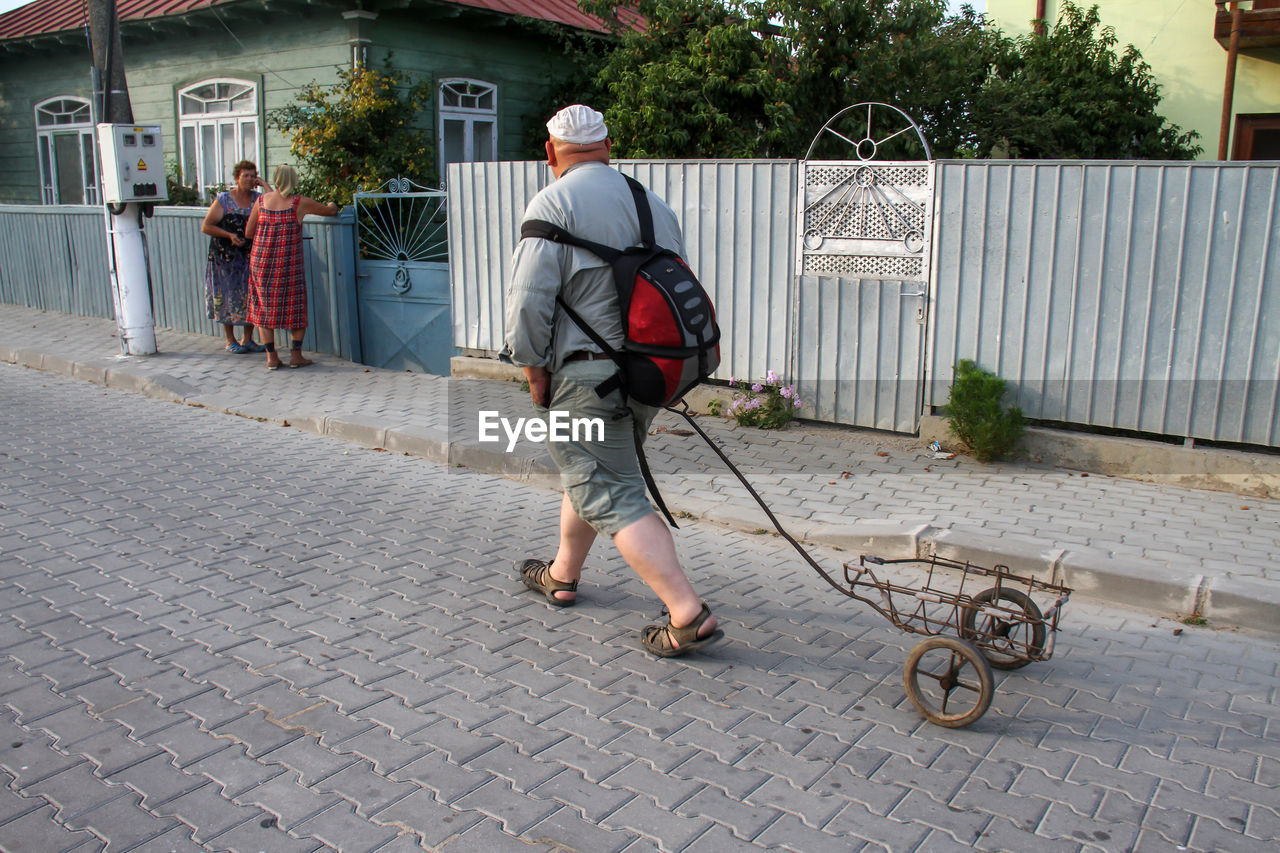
xmin=563 ymin=0 xmax=1198 ymax=159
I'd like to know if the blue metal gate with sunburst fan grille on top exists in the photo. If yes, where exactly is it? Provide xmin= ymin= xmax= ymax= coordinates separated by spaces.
xmin=355 ymin=178 xmax=456 ymax=375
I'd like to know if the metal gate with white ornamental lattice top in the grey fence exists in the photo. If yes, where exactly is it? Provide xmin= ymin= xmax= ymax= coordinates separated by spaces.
xmin=792 ymin=158 xmax=934 ymax=433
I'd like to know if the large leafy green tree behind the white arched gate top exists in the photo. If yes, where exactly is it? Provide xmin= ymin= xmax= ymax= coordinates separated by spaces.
xmin=581 ymin=0 xmax=1002 ymax=158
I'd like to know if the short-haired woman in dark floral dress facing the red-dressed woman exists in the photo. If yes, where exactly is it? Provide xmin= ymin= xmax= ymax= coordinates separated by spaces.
xmin=200 ymin=160 xmax=270 ymax=355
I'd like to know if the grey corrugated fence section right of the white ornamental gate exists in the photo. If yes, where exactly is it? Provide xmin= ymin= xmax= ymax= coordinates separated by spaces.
xmin=924 ymin=161 xmax=1280 ymax=447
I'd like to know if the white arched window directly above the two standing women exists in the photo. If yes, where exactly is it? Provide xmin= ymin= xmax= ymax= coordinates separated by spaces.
xmin=178 ymin=77 xmax=261 ymax=199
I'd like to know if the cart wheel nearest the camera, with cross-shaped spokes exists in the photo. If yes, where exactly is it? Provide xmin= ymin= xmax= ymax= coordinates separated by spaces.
xmin=902 ymin=637 xmax=996 ymax=729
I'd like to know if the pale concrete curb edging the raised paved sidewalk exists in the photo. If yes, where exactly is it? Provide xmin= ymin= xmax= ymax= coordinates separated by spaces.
xmin=10 ymin=350 xmax=1280 ymax=634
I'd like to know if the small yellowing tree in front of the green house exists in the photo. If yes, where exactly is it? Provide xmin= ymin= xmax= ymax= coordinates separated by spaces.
xmin=268 ymin=60 xmax=438 ymax=205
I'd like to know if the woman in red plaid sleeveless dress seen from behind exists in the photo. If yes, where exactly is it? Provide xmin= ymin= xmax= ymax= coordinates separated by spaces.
xmin=244 ymin=164 xmax=338 ymax=370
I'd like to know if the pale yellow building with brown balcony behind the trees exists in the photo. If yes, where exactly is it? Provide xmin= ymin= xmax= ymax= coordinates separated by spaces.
xmin=987 ymin=0 xmax=1280 ymax=160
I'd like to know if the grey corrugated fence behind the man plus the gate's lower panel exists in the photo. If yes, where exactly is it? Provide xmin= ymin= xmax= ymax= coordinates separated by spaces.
xmin=449 ymin=160 xmax=952 ymax=432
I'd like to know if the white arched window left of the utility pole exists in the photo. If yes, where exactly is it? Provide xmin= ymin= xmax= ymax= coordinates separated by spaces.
xmin=36 ymin=95 xmax=97 ymax=205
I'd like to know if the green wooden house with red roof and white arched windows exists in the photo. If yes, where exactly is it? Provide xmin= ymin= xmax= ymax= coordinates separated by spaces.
xmin=0 ymin=0 xmax=603 ymax=204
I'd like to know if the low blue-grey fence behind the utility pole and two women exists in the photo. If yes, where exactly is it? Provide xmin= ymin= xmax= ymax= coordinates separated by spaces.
xmin=0 ymin=205 xmax=360 ymax=360
